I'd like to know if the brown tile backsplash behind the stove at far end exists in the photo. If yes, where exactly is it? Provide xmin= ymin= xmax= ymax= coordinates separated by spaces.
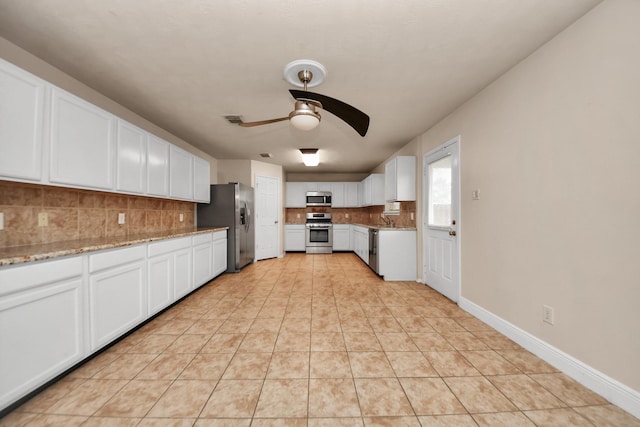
xmin=285 ymin=202 xmax=416 ymax=227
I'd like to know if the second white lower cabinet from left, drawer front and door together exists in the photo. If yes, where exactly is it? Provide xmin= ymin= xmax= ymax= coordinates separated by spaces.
xmin=89 ymin=245 xmax=147 ymax=351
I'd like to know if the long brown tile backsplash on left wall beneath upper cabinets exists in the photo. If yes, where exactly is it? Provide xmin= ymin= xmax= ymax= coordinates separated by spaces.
xmin=0 ymin=181 xmax=196 ymax=247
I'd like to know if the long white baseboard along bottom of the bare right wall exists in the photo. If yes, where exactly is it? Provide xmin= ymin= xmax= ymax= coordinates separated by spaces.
xmin=458 ymin=297 xmax=640 ymax=418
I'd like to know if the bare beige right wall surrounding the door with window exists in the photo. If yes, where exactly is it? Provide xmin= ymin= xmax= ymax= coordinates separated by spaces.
xmin=384 ymin=0 xmax=640 ymax=402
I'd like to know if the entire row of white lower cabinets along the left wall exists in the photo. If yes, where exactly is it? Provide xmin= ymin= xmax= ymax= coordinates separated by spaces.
xmin=0 ymin=230 xmax=227 ymax=410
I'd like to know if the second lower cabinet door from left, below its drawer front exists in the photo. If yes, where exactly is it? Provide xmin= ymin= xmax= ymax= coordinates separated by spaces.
xmin=89 ymin=261 xmax=147 ymax=351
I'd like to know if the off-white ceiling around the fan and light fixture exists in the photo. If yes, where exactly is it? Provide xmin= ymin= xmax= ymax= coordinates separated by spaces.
xmin=0 ymin=0 xmax=601 ymax=172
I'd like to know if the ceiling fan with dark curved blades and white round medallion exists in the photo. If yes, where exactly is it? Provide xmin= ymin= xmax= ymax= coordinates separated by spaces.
xmin=238 ymin=60 xmax=369 ymax=136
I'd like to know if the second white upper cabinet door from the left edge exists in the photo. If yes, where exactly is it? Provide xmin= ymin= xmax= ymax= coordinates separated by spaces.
xmin=49 ymin=88 xmax=115 ymax=190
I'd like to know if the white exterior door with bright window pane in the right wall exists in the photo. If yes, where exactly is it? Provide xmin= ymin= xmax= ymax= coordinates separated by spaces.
xmin=422 ymin=136 xmax=460 ymax=302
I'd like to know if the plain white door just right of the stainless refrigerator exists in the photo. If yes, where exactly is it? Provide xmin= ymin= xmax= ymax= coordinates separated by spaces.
xmin=255 ymin=175 xmax=281 ymax=261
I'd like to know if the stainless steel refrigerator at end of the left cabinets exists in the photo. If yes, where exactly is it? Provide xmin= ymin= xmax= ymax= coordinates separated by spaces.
xmin=198 ymin=182 xmax=255 ymax=273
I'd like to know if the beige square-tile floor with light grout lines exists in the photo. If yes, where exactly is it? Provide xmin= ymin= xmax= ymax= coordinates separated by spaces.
xmin=0 ymin=254 xmax=640 ymax=427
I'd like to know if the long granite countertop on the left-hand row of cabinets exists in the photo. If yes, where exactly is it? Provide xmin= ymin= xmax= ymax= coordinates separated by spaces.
xmin=0 ymin=227 xmax=228 ymax=266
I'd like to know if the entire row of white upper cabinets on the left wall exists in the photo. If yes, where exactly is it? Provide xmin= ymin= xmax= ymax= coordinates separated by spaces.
xmin=0 ymin=59 xmax=210 ymax=202
